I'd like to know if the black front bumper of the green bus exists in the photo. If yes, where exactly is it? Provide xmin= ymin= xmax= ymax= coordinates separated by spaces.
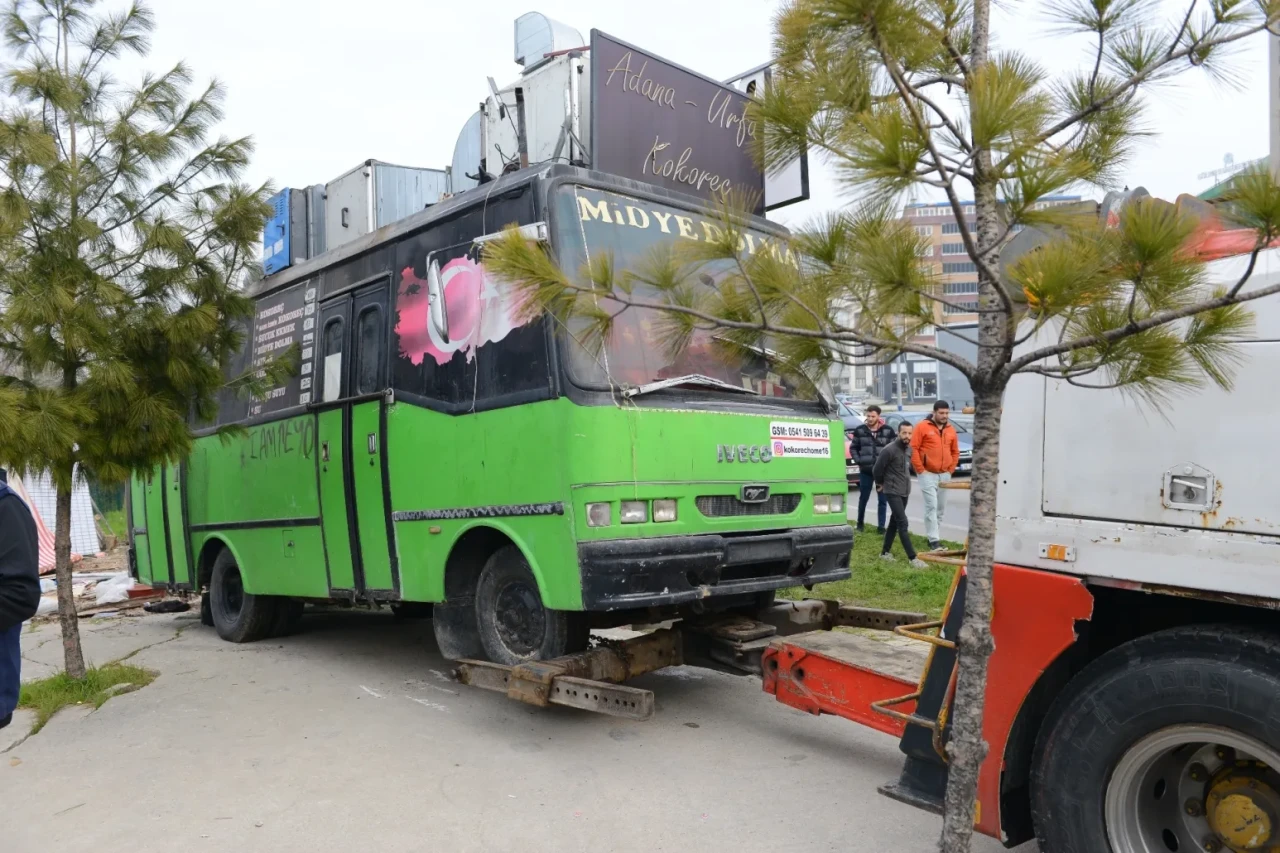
xmin=577 ymin=524 xmax=854 ymax=611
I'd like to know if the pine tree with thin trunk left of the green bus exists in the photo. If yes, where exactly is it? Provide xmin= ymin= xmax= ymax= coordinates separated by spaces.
xmin=0 ymin=0 xmax=269 ymax=678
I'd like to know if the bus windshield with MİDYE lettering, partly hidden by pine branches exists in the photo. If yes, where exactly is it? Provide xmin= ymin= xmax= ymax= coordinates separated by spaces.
xmin=556 ymin=186 xmax=818 ymax=401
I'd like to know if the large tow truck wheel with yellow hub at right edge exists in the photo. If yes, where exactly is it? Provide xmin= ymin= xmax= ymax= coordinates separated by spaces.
xmin=1032 ymin=625 xmax=1280 ymax=853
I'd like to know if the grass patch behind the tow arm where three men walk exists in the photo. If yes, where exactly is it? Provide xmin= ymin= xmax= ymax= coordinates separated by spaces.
xmin=778 ymin=528 xmax=960 ymax=619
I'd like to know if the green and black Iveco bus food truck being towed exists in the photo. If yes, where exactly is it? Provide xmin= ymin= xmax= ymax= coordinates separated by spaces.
xmin=129 ymin=165 xmax=852 ymax=663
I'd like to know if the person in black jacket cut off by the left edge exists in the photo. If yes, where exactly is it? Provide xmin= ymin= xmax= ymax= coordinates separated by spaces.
xmin=0 ymin=470 xmax=40 ymax=729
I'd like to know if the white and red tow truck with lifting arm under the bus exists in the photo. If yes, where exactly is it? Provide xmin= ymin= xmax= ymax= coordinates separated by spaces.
xmin=458 ymin=196 xmax=1280 ymax=853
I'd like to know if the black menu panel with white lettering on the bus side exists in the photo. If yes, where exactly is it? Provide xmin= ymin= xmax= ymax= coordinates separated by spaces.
xmin=248 ymin=280 xmax=319 ymax=418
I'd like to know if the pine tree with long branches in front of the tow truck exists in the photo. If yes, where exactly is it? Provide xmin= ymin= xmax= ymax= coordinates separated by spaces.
xmin=485 ymin=0 xmax=1280 ymax=853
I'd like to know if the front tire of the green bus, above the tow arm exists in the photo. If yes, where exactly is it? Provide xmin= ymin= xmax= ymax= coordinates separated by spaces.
xmin=476 ymin=546 xmax=588 ymax=666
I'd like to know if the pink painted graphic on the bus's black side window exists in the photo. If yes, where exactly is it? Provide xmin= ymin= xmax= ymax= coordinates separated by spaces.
xmin=396 ymin=257 xmax=532 ymax=365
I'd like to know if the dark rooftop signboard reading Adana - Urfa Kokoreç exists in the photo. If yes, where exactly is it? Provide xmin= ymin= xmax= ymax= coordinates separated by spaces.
xmin=591 ymin=29 xmax=764 ymax=214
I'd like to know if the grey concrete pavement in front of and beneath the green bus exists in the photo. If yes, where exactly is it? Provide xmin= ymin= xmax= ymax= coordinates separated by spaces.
xmin=0 ymin=612 xmax=1025 ymax=853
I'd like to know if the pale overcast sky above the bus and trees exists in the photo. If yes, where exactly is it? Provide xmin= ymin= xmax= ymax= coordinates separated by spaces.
xmin=129 ymin=0 xmax=1267 ymax=222
